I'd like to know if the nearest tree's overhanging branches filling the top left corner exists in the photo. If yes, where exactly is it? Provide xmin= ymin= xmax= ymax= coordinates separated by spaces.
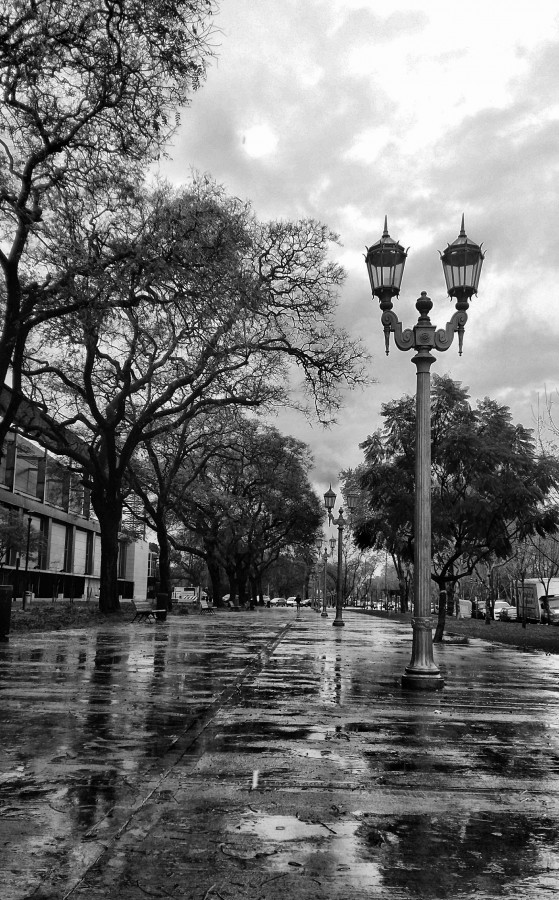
xmin=0 ymin=0 xmax=215 ymax=446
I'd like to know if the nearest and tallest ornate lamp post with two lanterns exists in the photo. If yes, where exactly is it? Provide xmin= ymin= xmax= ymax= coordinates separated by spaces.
xmin=365 ymin=216 xmax=484 ymax=690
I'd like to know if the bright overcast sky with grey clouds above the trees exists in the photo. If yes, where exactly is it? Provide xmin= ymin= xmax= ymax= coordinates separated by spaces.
xmin=162 ymin=0 xmax=559 ymax=502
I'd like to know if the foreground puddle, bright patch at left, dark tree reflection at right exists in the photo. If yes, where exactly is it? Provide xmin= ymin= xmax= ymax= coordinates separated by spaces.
xmin=228 ymin=811 xmax=559 ymax=900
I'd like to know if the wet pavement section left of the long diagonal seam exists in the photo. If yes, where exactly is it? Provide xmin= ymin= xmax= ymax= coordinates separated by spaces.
xmin=0 ymin=617 xmax=281 ymax=900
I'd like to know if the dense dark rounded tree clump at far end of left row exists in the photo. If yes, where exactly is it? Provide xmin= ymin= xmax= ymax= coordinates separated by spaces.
xmin=171 ymin=420 xmax=323 ymax=602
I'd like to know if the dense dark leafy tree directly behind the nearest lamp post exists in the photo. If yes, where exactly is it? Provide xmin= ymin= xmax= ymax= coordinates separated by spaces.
xmin=358 ymin=376 xmax=559 ymax=640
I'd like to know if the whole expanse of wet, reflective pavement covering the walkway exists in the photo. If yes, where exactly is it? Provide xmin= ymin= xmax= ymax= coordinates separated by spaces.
xmin=0 ymin=609 xmax=559 ymax=900
